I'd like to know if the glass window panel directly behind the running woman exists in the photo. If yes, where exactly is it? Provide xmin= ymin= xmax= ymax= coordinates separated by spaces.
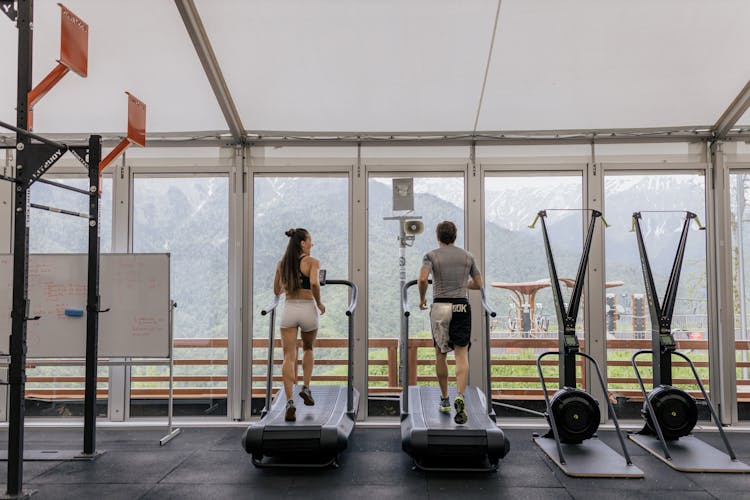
xmin=252 ymin=176 xmax=349 ymax=409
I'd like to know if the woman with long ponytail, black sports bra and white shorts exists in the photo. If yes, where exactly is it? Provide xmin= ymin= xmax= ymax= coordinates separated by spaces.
xmin=273 ymin=227 xmax=326 ymax=422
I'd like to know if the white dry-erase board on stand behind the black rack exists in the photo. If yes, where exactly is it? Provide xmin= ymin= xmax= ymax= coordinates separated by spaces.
xmin=0 ymin=254 xmax=171 ymax=358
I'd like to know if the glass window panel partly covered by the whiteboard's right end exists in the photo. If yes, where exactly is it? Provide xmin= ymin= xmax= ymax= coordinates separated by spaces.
xmin=130 ymin=176 xmax=229 ymax=417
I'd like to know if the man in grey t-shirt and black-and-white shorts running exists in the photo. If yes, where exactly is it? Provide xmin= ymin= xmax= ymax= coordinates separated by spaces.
xmin=418 ymin=221 xmax=483 ymax=424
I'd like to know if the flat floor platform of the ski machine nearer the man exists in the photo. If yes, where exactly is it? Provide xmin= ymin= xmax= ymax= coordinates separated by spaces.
xmin=534 ymin=437 xmax=643 ymax=478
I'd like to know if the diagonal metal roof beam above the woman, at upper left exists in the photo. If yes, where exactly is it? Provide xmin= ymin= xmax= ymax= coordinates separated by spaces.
xmin=175 ymin=0 xmax=245 ymax=143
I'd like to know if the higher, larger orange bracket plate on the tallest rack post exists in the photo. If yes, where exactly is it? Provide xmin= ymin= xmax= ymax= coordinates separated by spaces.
xmin=28 ymin=3 xmax=89 ymax=130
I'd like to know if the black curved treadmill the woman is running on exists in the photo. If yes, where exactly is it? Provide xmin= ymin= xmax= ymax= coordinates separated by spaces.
xmin=242 ymin=280 xmax=359 ymax=467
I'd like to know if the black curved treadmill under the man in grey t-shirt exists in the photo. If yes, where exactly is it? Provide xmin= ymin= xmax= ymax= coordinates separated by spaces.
xmin=401 ymin=280 xmax=510 ymax=471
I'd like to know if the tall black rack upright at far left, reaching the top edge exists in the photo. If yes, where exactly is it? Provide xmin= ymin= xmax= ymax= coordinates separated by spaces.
xmin=6 ymin=0 xmax=34 ymax=496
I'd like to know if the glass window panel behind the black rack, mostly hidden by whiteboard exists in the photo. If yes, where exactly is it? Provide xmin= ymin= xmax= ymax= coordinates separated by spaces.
xmin=26 ymin=175 xmax=112 ymax=417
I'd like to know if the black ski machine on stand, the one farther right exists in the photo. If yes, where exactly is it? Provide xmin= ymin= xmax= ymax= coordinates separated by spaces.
xmin=629 ymin=211 xmax=750 ymax=472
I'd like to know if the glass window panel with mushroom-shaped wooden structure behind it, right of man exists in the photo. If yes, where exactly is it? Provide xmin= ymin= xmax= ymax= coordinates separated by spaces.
xmin=484 ymin=172 xmax=584 ymax=418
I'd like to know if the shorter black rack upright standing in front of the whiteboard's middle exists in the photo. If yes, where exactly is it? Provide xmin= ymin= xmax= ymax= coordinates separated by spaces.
xmin=83 ymin=135 xmax=102 ymax=456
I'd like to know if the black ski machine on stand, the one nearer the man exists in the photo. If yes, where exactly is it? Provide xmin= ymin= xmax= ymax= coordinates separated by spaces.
xmin=529 ymin=210 xmax=643 ymax=478
